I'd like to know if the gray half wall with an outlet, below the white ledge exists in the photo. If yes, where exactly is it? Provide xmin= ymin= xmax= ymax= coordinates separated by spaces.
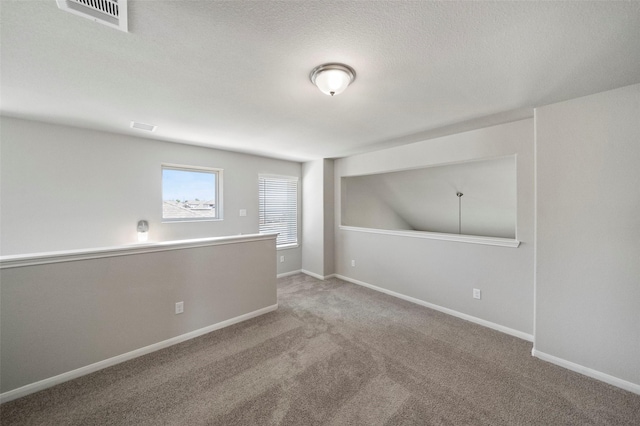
xmin=0 ymin=237 xmax=277 ymax=393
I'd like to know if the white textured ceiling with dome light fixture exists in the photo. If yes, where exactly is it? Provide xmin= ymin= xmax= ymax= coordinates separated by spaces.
xmin=0 ymin=0 xmax=640 ymax=161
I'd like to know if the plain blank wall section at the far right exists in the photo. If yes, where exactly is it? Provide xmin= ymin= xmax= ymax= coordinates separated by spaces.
xmin=535 ymin=85 xmax=640 ymax=385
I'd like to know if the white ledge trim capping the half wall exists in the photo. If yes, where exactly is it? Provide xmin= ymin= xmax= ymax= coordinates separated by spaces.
xmin=0 ymin=234 xmax=278 ymax=269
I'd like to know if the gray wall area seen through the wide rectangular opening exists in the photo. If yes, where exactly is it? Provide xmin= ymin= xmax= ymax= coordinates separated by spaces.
xmin=341 ymin=156 xmax=517 ymax=239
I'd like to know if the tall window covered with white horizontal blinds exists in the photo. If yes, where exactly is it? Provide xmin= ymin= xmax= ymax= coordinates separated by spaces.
xmin=258 ymin=175 xmax=298 ymax=248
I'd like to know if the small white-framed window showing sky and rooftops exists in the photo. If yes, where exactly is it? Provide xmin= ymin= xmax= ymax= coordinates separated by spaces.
xmin=162 ymin=165 xmax=222 ymax=222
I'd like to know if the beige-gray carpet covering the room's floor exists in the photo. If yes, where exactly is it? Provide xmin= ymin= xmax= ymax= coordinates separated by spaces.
xmin=0 ymin=275 xmax=640 ymax=426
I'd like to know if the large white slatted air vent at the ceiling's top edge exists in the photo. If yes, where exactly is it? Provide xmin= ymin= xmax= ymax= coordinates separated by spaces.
xmin=56 ymin=0 xmax=129 ymax=32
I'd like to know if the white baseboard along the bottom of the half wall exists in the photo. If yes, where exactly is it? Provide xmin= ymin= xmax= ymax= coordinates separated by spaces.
xmin=0 ymin=303 xmax=278 ymax=403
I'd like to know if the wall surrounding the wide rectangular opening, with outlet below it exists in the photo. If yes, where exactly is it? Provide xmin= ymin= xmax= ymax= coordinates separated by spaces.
xmin=335 ymin=119 xmax=534 ymax=335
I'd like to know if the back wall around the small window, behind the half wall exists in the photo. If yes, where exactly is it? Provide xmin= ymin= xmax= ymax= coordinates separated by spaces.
xmin=0 ymin=117 xmax=301 ymax=273
